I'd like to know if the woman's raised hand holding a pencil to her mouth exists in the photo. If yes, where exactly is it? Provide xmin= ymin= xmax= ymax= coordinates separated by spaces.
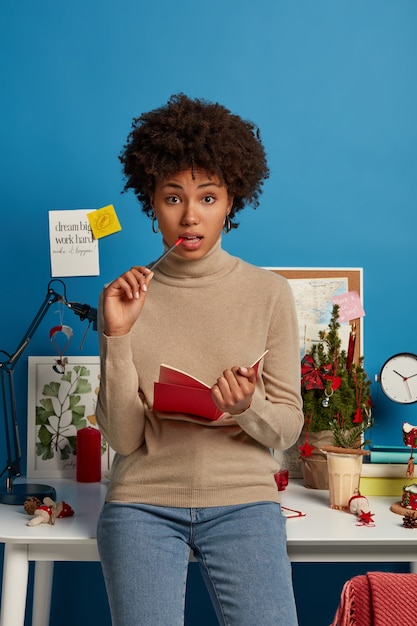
xmin=103 ymin=266 xmax=153 ymax=337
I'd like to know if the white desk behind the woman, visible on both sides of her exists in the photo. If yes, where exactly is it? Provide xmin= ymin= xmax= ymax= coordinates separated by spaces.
xmin=0 ymin=480 xmax=417 ymax=626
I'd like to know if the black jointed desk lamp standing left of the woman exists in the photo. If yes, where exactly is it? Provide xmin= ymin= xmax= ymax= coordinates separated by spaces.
xmin=0 ymin=279 xmax=97 ymax=504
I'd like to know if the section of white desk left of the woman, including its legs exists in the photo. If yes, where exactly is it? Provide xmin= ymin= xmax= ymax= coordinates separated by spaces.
xmin=0 ymin=480 xmax=106 ymax=626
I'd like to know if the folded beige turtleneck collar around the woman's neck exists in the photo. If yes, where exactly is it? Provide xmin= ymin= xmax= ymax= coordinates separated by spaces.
xmin=154 ymin=237 xmax=238 ymax=284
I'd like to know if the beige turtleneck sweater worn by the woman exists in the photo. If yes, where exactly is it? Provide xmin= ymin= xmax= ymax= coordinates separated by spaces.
xmin=97 ymin=240 xmax=303 ymax=507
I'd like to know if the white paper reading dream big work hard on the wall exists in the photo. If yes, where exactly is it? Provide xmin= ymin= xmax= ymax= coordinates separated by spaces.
xmin=49 ymin=209 xmax=100 ymax=277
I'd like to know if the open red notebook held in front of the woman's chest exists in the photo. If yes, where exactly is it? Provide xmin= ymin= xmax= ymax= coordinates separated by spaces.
xmin=153 ymin=350 xmax=268 ymax=420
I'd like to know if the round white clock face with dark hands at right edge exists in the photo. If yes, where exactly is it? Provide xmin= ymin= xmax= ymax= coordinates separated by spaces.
xmin=379 ymin=352 xmax=417 ymax=404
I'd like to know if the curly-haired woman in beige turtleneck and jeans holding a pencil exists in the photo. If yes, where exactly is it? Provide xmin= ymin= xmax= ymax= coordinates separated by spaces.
xmin=97 ymin=94 xmax=303 ymax=626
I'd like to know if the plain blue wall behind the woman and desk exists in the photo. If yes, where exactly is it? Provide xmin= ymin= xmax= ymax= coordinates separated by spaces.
xmin=0 ymin=0 xmax=417 ymax=626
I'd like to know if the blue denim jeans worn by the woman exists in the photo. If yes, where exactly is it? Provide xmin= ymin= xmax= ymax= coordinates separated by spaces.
xmin=97 ymin=502 xmax=298 ymax=626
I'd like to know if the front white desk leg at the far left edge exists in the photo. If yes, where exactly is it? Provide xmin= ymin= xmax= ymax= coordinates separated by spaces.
xmin=0 ymin=543 xmax=29 ymax=626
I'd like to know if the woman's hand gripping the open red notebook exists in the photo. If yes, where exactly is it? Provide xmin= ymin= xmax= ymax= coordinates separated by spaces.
xmin=211 ymin=367 xmax=256 ymax=415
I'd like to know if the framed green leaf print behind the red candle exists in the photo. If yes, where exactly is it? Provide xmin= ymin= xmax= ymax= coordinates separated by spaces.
xmin=27 ymin=356 xmax=113 ymax=478
